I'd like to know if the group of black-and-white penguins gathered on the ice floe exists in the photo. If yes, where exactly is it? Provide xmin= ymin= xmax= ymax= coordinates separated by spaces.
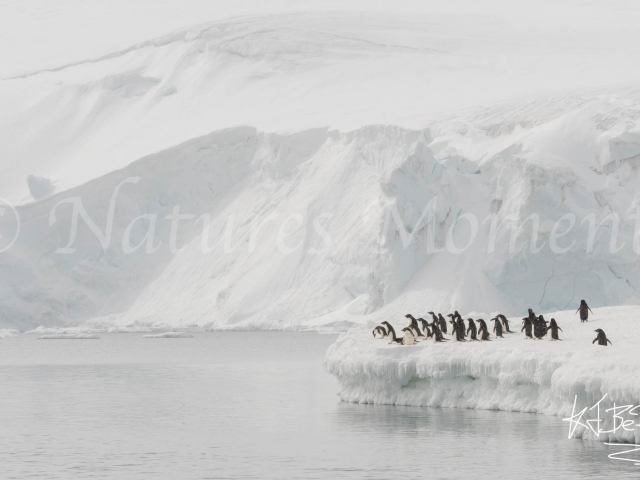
xmin=372 ymin=300 xmax=613 ymax=346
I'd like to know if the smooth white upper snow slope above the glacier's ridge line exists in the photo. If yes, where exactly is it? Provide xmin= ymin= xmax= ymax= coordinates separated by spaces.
xmin=0 ymin=5 xmax=640 ymax=203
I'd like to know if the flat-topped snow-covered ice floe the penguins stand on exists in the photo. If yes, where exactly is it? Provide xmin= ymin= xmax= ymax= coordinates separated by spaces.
xmin=325 ymin=306 xmax=640 ymax=443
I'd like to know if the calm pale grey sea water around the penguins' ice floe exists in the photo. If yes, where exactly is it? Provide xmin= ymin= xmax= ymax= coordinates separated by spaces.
xmin=0 ymin=332 xmax=640 ymax=480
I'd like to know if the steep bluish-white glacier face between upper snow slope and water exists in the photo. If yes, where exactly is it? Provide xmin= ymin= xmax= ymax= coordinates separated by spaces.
xmin=0 ymin=90 xmax=640 ymax=330
